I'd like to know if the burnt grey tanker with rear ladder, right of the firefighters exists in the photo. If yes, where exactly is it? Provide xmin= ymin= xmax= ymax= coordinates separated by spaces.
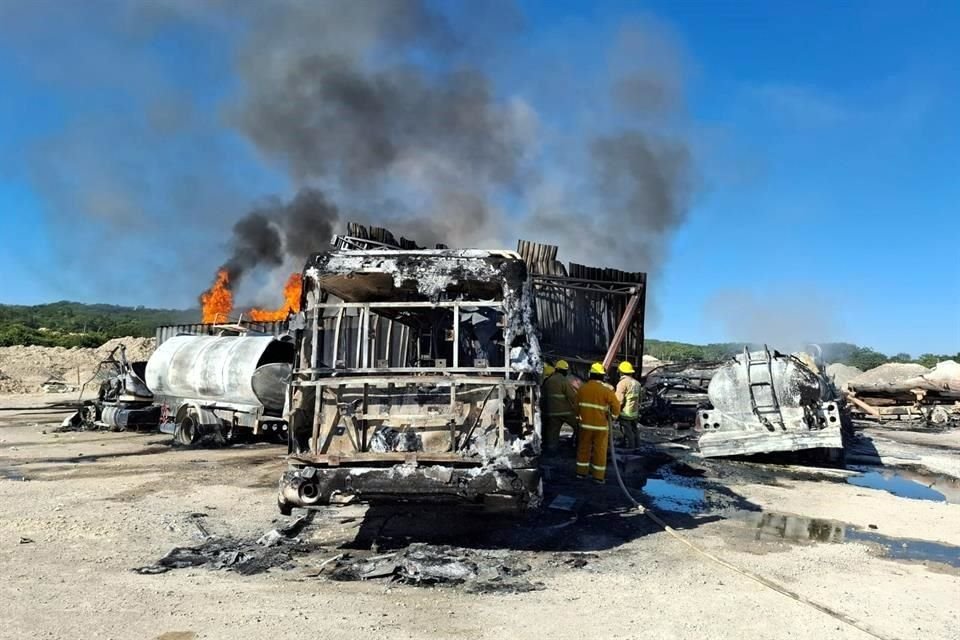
xmin=697 ymin=347 xmax=843 ymax=457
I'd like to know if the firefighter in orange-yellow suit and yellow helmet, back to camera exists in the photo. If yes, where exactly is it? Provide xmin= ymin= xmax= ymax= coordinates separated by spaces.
xmin=577 ymin=362 xmax=620 ymax=484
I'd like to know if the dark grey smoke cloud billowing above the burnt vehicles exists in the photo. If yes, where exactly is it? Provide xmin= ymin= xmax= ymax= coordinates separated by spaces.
xmin=0 ymin=0 xmax=696 ymax=310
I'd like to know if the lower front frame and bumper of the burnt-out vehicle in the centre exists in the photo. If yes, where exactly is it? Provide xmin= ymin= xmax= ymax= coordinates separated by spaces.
xmin=279 ymin=376 xmax=540 ymax=514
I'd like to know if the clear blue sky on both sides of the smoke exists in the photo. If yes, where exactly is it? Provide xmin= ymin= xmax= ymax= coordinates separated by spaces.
xmin=0 ymin=0 xmax=960 ymax=355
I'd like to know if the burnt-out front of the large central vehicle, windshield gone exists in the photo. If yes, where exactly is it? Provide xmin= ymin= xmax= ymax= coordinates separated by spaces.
xmin=278 ymin=246 xmax=542 ymax=513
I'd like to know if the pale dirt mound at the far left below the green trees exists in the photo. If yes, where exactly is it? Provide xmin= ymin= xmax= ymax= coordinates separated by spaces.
xmin=0 ymin=337 xmax=156 ymax=393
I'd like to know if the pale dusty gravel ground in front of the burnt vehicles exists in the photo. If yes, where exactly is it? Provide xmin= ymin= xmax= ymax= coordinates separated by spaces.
xmin=0 ymin=396 xmax=960 ymax=640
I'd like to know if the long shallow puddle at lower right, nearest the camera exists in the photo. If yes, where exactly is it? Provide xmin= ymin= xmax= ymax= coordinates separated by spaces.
xmin=732 ymin=512 xmax=960 ymax=569
